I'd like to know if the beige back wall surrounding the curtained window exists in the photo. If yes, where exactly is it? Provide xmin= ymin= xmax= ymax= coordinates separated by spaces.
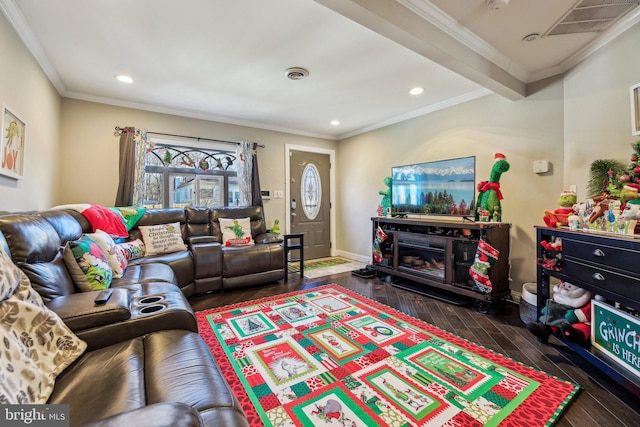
xmin=60 ymin=98 xmax=336 ymax=230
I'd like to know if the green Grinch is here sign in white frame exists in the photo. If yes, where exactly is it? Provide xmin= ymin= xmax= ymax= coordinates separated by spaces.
xmin=591 ymin=300 xmax=640 ymax=378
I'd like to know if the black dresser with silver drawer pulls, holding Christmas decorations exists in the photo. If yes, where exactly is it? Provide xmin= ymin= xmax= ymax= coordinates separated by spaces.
xmin=536 ymin=227 xmax=640 ymax=397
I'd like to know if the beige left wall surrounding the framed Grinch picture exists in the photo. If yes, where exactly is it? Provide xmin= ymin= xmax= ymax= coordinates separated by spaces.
xmin=0 ymin=14 xmax=60 ymax=211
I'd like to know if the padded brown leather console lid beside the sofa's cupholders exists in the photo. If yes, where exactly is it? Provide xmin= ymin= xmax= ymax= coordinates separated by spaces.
xmin=46 ymin=288 xmax=131 ymax=331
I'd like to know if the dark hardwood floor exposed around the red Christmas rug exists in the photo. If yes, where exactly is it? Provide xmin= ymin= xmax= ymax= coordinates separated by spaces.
xmin=190 ymin=273 xmax=640 ymax=427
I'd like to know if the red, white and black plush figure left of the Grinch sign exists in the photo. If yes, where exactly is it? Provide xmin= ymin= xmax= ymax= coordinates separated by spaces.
xmin=527 ymin=282 xmax=599 ymax=343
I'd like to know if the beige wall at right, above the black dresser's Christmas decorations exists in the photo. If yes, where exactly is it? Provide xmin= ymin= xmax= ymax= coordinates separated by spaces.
xmin=564 ymin=24 xmax=640 ymax=199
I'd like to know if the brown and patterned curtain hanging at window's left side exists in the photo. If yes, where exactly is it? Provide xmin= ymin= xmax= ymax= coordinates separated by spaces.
xmin=114 ymin=127 xmax=148 ymax=206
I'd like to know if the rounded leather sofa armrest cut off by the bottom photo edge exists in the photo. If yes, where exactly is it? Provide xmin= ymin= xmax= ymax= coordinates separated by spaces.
xmin=85 ymin=402 xmax=204 ymax=427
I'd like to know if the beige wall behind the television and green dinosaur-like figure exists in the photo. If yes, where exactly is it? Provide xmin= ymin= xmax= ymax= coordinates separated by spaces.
xmin=337 ymin=82 xmax=563 ymax=290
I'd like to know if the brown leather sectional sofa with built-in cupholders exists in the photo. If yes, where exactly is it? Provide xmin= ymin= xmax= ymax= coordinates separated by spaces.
xmin=0 ymin=207 xmax=284 ymax=426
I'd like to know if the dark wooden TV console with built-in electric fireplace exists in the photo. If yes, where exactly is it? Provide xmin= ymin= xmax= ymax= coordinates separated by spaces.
xmin=371 ymin=217 xmax=511 ymax=313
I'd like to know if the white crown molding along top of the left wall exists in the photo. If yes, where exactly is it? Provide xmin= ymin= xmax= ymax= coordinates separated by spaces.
xmin=0 ymin=0 xmax=67 ymax=96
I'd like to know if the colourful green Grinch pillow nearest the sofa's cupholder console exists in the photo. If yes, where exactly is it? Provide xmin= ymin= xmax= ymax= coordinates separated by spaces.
xmin=63 ymin=236 xmax=113 ymax=292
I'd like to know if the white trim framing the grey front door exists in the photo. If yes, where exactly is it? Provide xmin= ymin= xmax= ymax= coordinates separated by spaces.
xmin=284 ymin=144 xmax=336 ymax=256
